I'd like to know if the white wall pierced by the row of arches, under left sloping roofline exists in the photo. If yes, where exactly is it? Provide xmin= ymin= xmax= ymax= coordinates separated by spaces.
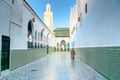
xmin=22 ymin=3 xmax=53 ymax=46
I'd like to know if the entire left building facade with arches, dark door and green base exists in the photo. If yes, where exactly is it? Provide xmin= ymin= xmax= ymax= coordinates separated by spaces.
xmin=0 ymin=0 xmax=56 ymax=75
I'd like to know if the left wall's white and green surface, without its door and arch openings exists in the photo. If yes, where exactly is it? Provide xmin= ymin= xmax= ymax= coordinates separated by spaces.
xmin=0 ymin=0 xmax=53 ymax=74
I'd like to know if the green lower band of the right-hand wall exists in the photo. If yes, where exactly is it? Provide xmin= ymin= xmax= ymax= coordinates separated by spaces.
xmin=75 ymin=47 xmax=120 ymax=80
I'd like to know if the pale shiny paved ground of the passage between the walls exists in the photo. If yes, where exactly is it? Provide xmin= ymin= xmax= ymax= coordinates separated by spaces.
xmin=0 ymin=52 xmax=106 ymax=80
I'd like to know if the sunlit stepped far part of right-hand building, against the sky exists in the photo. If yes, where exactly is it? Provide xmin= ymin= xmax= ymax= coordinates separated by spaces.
xmin=70 ymin=0 xmax=88 ymax=47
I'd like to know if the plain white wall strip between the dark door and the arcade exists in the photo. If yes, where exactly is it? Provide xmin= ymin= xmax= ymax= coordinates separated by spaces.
xmin=10 ymin=0 xmax=23 ymax=49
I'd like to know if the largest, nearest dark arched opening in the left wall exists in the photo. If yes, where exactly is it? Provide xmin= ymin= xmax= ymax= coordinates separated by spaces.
xmin=27 ymin=20 xmax=33 ymax=48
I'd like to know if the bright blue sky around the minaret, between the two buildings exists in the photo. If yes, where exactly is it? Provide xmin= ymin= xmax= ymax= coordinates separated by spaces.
xmin=28 ymin=0 xmax=76 ymax=28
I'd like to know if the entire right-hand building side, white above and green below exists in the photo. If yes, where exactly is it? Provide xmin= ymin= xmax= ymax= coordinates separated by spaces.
xmin=70 ymin=0 xmax=120 ymax=80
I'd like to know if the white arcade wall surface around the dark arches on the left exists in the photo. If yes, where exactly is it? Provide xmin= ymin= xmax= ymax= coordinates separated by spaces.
xmin=23 ymin=1 xmax=51 ymax=48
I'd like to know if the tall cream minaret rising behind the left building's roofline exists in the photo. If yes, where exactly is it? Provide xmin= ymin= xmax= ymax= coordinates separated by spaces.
xmin=44 ymin=3 xmax=53 ymax=31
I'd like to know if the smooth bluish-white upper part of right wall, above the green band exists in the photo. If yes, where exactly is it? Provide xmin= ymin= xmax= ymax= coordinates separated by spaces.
xmin=71 ymin=0 xmax=120 ymax=47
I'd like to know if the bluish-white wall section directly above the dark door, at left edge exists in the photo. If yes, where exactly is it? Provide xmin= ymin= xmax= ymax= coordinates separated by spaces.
xmin=0 ymin=0 xmax=12 ymax=50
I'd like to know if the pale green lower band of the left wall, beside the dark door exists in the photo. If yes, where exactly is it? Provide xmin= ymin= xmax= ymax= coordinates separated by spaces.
xmin=10 ymin=48 xmax=47 ymax=70
